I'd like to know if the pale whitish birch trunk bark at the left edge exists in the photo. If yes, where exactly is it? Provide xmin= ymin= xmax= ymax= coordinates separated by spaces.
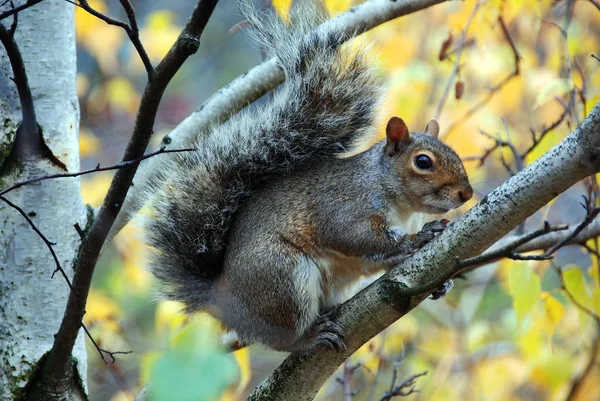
xmin=0 ymin=0 xmax=87 ymax=399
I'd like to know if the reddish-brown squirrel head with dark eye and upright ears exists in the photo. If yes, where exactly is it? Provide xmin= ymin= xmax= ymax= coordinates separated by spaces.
xmin=383 ymin=117 xmax=473 ymax=214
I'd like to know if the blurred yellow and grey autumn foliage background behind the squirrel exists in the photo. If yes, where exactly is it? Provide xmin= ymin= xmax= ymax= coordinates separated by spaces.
xmin=76 ymin=0 xmax=600 ymax=401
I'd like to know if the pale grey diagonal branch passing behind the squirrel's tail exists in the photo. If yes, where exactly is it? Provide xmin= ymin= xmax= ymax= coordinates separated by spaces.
xmin=109 ymin=0 xmax=448 ymax=239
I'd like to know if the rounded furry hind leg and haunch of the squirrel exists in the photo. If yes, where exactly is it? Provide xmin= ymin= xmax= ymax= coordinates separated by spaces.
xmin=214 ymin=250 xmax=322 ymax=352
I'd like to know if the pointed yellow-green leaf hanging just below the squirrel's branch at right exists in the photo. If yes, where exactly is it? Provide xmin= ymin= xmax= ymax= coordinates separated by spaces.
xmin=508 ymin=263 xmax=542 ymax=322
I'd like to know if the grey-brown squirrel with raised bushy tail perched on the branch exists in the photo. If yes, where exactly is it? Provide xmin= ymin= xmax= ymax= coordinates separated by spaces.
xmin=144 ymin=1 xmax=473 ymax=352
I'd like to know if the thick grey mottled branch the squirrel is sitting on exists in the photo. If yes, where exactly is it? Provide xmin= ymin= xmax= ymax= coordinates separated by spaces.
xmin=249 ymin=103 xmax=600 ymax=400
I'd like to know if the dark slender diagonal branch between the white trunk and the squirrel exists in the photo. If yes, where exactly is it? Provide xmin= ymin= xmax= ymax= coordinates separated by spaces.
xmin=43 ymin=0 xmax=216 ymax=389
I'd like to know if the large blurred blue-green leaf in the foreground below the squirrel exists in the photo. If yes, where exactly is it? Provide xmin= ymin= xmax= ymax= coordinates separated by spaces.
xmin=150 ymin=323 xmax=238 ymax=401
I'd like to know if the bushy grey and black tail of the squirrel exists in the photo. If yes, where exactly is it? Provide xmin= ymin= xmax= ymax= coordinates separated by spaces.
xmin=145 ymin=0 xmax=381 ymax=311
